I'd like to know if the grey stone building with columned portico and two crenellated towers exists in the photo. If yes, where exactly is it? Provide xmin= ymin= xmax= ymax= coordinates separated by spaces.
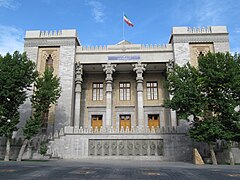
xmin=20 ymin=26 xmax=229 ymax=161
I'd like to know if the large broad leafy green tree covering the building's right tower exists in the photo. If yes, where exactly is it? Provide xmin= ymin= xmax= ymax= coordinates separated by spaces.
xmin=165 ymin=53 xmax=240 ymax=164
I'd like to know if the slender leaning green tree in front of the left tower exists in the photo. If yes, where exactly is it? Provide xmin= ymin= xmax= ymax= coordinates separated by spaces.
xmin=17 ymin=68 xmax=61 ymax=161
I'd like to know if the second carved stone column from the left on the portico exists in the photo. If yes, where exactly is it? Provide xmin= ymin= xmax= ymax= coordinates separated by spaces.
xmin=102 ymin=63 xmax=116 ymax=128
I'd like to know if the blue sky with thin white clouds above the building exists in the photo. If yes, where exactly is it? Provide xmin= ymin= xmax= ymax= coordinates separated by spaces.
xmin=0 ymin=0 xmax=240 ymax=54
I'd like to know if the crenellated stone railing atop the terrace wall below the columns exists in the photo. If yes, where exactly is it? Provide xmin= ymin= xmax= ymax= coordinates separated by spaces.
xmin=48 ymin=126 xmax=187 ymax=139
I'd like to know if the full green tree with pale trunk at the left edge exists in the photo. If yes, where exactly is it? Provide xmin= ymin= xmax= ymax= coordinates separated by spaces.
xmin=0 ymin=51 xmax=37 ymax=161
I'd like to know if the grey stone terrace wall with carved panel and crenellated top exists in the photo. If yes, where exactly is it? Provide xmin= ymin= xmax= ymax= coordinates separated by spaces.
xmin=48 ymin=127 xmax=192 ymax=161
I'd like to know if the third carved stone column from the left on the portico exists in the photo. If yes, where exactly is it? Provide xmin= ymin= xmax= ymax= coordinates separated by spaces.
xmin=133 ymin=62 xmax=147 ymax=127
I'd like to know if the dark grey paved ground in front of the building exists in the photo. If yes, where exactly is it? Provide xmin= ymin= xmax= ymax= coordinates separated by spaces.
xmin=0 ymin=159 xmax=240 ymax=180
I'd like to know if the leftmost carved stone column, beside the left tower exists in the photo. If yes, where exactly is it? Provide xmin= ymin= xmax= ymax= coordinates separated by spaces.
xmin=74 ymin=62 xmax=83 ymax=128
